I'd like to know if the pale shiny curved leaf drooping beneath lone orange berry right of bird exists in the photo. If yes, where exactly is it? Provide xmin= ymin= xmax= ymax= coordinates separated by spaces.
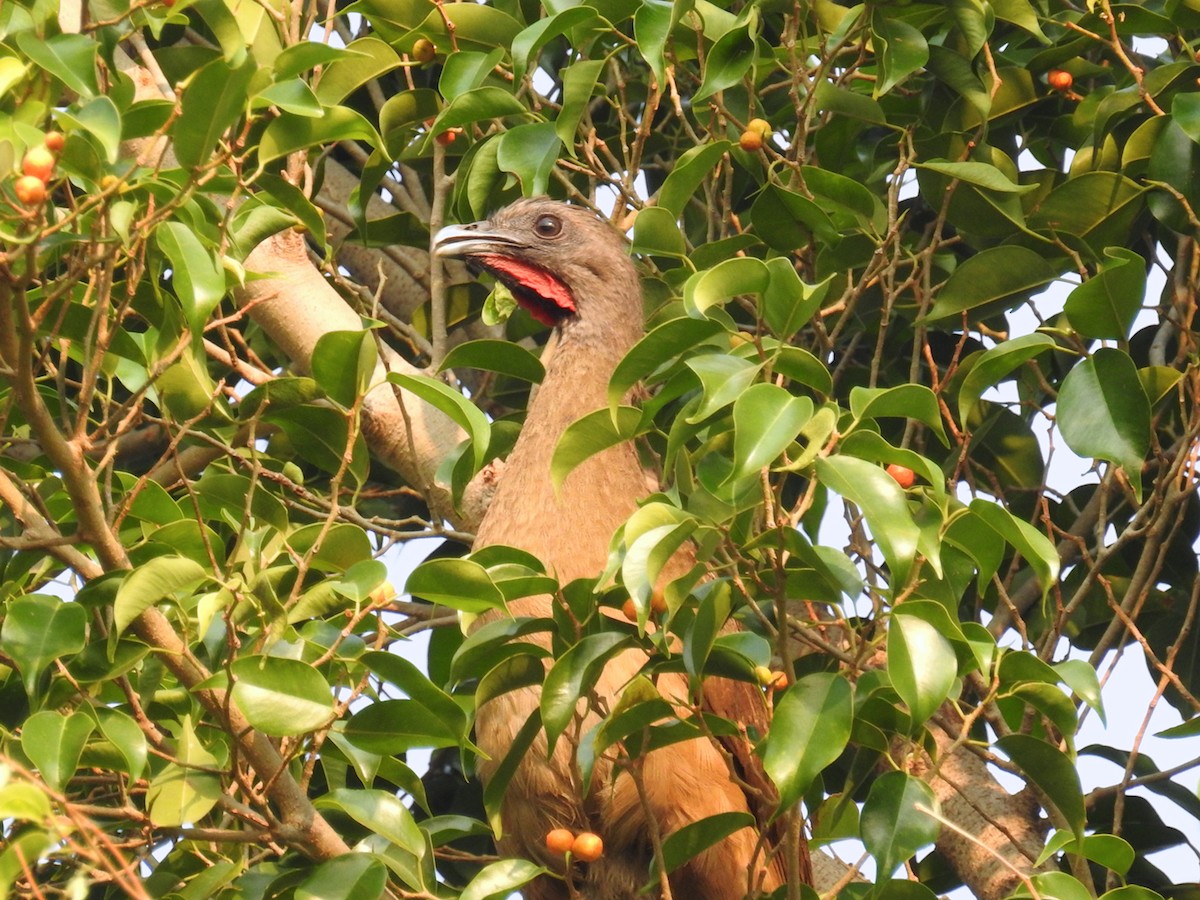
xmin=816 ymin=456 xmax=920 ymax=584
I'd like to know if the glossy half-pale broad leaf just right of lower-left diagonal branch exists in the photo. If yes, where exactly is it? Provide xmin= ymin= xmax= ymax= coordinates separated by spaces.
xmin=230 ymin=656 xmax=334 ymax=738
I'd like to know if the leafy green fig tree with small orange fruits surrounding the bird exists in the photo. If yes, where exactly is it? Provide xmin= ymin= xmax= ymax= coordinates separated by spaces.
xmin=0 ymin=0 xmax=1200 ymax=898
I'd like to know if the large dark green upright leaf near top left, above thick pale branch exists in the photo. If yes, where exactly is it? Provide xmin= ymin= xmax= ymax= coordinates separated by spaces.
xmin=172 ymin=54 xmax=258 ymax=169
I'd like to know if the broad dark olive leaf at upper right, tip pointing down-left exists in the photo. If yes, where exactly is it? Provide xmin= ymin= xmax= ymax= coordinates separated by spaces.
xmin=925 ymin=246 xmax=1058 ymax=322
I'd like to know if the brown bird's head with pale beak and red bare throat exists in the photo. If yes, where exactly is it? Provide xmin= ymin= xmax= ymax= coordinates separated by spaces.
xmin=433 ymin=198 xmax=642 ymax=338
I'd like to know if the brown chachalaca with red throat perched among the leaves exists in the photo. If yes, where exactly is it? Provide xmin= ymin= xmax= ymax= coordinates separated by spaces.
xmin=434 ymin=199 xmax=810 ymax=900
